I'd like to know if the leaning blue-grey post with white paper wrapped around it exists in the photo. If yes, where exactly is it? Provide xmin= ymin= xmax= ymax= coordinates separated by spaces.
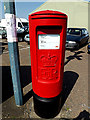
xmin=4 ymin=0 xmax=23 ymax=106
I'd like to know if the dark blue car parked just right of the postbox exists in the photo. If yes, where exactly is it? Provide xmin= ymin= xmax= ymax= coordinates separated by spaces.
xmin=66 ymin=28 xmax=89 ymax=49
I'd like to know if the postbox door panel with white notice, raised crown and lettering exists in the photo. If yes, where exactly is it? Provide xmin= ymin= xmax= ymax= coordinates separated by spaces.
xmin=37 ymin=27 xmax=62 ymax=82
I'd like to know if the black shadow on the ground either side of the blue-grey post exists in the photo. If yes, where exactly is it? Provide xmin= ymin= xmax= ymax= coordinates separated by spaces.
xmin=2 ymin=66 xmax=32 ymax=102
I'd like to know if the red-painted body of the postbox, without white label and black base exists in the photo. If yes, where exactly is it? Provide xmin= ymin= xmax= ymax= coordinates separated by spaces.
xmin=29 ymin=10 xmax=67 ymax=98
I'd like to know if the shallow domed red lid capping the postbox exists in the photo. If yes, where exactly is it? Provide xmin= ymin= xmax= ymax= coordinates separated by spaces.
xmin=31 ymin=10 xmax=67 ymax=18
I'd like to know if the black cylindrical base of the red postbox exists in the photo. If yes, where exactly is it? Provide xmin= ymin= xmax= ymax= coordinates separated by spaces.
xmin=33 ymin=93 xmax=61 ymax=119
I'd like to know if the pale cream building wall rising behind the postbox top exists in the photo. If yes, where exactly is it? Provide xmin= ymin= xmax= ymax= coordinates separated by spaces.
xmin=30 ymin=0 xmax=90 ymax=34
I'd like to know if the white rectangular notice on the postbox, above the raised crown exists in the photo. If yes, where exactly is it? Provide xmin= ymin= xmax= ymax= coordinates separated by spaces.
xmin=38 ymin=34 xmax=60 ymax=49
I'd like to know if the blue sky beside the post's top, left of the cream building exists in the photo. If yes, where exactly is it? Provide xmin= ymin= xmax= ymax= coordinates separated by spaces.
xmin=0 ymin=0 xmax=90 ymax=19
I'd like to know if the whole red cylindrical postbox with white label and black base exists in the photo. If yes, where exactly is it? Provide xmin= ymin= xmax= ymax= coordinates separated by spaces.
xmin=29 ymin=10 xmax=67 ymax=118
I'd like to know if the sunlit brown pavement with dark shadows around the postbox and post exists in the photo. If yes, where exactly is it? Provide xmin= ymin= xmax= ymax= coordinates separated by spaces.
xmin=0 ymin=40 xmax=90 ymax=120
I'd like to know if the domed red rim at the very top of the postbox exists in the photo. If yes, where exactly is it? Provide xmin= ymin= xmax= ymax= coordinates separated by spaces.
xmin=30 ymin=10 xmax=67 ymax=18
